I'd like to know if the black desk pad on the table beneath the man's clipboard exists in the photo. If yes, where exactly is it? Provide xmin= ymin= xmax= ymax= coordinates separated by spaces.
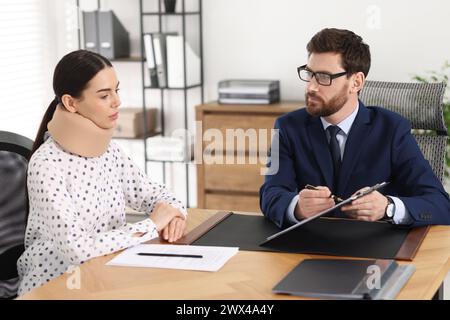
xmin=191 ymin=214 xmax=421 ymax=260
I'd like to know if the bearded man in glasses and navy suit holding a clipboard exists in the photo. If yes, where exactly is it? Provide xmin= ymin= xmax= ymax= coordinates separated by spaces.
xmin=260 ymin=29 xmax=450 ymax=228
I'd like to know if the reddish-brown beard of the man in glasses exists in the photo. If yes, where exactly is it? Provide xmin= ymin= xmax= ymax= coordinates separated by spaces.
xmin=305 ymin=86 xmax=348 ymax=117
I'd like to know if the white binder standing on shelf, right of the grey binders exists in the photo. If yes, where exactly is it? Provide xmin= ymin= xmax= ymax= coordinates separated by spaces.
xmin=166 ymin=35 xmax=200 ymax=88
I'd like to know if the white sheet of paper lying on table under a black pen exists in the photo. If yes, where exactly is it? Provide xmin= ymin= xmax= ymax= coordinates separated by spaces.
xmin=106 ymin=244 xmax=239 ymax=271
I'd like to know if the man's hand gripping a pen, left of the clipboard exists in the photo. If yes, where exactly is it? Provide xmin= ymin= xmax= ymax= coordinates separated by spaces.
xmin=294 ymin=186 xmax=335 ymax=220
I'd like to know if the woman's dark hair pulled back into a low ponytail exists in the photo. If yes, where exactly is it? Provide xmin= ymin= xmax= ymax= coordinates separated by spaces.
xmin=30 ymin=50 xmax=112 ymax=158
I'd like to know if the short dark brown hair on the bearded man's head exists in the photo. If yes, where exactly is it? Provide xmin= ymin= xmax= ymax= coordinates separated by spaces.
xmin=306 ymin=28 xmax=370 ymax=77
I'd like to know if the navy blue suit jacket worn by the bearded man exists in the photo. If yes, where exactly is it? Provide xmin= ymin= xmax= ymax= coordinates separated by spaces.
xmin=260 ymin=101 xmax=450 ymax=228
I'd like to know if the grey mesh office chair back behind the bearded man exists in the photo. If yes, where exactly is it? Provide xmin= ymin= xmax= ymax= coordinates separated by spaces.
xmin=359 ymin=81 xmax=448 ymax=182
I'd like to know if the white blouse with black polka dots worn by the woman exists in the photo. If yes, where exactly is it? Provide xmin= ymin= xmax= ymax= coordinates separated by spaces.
xmin=17 ymin=137 xmax=186 ymax=295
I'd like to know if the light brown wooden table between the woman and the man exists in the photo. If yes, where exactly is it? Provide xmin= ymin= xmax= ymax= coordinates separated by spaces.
xmin=20 ymin=209 xmax=450 ymax=300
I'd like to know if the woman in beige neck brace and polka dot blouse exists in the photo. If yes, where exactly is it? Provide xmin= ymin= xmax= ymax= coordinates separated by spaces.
xmin=17 ymin=50 xmax=186 ymax=295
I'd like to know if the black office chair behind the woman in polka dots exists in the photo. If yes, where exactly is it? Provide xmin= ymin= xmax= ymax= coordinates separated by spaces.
xmin=0 ymin=131 xmax=33 ymax=299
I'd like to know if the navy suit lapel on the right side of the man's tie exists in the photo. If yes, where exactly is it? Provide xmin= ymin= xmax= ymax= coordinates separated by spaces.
xmin=337 ymin=101 xmax=372 ymax=194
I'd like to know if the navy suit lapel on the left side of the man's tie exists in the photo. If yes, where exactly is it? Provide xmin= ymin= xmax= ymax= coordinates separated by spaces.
xmin=307 ymin=117 xmax=333 ymax=190
